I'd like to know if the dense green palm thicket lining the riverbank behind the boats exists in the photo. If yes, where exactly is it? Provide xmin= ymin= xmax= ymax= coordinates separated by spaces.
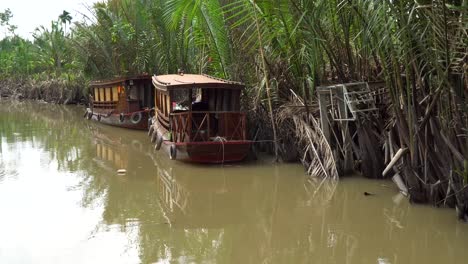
xmin=0 ymin=0 xmax=468 ymax=217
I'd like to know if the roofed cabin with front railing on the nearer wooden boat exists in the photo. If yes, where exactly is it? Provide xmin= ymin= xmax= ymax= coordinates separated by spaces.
xmin=153 ymin=74 xmax=246 ymax=142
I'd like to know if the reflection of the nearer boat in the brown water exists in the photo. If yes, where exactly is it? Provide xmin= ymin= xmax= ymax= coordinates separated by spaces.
xmin=153 ymin=154 xmax=251 ymax=228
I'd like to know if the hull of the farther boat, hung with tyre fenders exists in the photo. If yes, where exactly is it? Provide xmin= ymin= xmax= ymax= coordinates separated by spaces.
xmin=87 ymin=109 xmax=149 ymax=130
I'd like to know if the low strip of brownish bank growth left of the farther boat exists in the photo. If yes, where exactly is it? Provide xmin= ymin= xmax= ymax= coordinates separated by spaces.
xmin=0 ymin=79 xmax=87 ymax=104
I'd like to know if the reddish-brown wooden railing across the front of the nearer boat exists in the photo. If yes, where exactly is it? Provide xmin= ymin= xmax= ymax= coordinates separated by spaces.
xmin=169 ymin=111 xmax=246 ymax=143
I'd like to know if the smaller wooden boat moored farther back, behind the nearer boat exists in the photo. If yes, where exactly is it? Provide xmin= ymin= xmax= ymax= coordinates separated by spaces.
xmin=85 ymin=75 xmax=154 ymax=130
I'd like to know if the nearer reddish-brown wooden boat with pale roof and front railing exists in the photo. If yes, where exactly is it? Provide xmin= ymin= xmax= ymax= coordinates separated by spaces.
xmin=149 ymin=73 xmax=251 ymax=163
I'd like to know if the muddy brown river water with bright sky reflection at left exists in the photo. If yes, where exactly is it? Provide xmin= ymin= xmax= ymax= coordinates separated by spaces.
xmin=0 ymin=101 xmax=468 ymax=264
